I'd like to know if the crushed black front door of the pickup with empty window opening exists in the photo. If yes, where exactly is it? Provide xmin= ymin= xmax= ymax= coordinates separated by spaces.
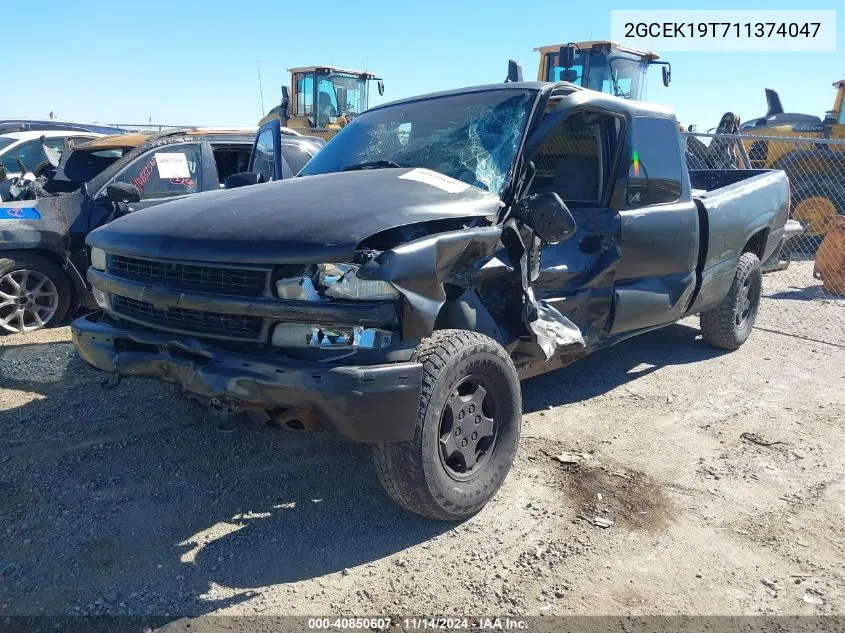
xmin=529 ymin=111 xmax=624 ymax=346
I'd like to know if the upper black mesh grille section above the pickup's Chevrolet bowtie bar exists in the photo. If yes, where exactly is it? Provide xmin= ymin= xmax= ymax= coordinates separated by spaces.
xmin=109 ymin=255 xmax=268 ymax=297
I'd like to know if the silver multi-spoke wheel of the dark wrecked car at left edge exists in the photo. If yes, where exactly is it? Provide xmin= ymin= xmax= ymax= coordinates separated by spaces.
xmin=0 ymin=253 xmax=70 ymax=332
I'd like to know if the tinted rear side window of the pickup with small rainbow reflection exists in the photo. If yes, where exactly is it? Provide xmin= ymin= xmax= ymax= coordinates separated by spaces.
xmin=626 ymin=117 xmax=683 ymax=207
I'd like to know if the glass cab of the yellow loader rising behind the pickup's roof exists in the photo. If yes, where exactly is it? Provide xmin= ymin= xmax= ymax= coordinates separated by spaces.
xmin=534 ymin=41 xmax=672 ymax=101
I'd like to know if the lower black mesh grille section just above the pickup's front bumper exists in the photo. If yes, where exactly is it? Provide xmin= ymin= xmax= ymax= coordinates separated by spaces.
xmin=112 ymin=295 xmax=263 ymax=339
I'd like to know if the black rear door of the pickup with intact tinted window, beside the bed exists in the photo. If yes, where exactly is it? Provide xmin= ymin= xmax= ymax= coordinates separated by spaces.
xmin=610 ymin=116 xmax=699 ymax=334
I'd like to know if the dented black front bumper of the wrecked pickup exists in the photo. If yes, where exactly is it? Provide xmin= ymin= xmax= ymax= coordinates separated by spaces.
xmin=71 ymin=312 xmax=422 ymax=442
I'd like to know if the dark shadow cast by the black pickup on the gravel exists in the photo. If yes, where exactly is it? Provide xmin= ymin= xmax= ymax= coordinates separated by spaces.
xmin=0 ymin=318 xmax=720 ymax=617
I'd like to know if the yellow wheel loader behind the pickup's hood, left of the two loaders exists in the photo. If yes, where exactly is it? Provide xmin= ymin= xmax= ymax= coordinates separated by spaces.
xmin=258 ymin=66 xmax=384 ymax=141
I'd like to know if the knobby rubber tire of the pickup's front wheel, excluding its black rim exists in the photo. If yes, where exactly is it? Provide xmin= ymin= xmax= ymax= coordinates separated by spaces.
xmin=373 ymin=330 xmax=522 ymax=521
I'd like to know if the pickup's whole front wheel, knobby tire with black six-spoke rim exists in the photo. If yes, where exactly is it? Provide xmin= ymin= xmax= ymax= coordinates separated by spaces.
xmin=373 ymin=330 xmax=522 ymax=521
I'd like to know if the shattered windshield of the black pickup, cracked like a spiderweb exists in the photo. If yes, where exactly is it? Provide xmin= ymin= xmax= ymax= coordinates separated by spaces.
xmin=300 ymin=89 xmax=535 ymax=194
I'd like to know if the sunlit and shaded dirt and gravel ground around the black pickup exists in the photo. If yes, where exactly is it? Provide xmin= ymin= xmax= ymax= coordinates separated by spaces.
xmin=0 ymin=301 xmax=845 ymax=618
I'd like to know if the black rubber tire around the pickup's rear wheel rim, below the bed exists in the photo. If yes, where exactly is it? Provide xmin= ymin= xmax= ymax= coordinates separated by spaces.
xmin=701 ymin=253 xmax=763 ymax=350
